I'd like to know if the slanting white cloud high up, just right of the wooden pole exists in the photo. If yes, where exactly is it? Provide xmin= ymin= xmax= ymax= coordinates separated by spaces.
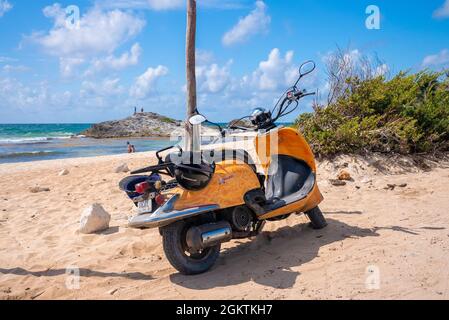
xmin=222 ymin=1 xmax=271 ymax=46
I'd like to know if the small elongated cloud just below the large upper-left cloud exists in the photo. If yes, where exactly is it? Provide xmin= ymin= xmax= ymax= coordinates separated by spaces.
xmin=85 ymin=43 xmax=142 ymax=76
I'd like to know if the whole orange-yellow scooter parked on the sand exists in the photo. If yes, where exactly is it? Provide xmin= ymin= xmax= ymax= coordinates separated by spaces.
xmin=120 ymin=61 xmax=326 ymax=275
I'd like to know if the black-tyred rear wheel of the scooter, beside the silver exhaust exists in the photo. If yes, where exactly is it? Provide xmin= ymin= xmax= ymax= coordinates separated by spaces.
xmin=161 ymin=221 xmax=221 ymax=275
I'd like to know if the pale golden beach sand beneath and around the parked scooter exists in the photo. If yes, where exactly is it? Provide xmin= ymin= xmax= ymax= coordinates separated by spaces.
xmin=0 ymin=148 xmax=449 ymax=300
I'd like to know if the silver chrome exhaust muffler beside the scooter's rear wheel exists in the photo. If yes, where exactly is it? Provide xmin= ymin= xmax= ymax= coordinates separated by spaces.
xmin=186 ymin=221 xmax=232 ymax=251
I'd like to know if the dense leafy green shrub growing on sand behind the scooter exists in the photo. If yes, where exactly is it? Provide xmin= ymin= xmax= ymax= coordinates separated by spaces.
xmin=295 ymin=70 xmax=449 ymax=156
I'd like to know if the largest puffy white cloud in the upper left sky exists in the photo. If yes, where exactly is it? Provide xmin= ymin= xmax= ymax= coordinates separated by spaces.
xmin=31 ymin=4 xmax=145 ymax=58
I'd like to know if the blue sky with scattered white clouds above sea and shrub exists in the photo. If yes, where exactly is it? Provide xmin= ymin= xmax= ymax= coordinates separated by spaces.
xmin=0 ymin=0 xmax=449 ymax=123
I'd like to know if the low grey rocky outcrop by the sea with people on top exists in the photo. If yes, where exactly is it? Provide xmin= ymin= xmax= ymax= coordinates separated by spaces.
xmin=81 ymin=112 xmax=182 ymax=139
